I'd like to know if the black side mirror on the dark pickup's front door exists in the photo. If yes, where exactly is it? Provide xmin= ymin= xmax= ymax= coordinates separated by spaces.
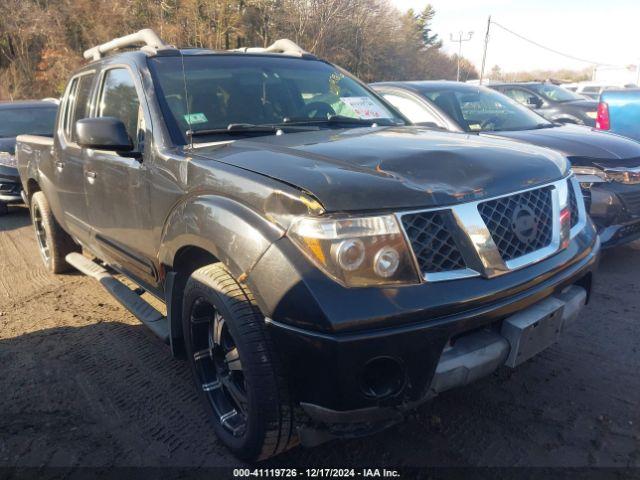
xmin=75 ymin=117 xmax=133 ymax=152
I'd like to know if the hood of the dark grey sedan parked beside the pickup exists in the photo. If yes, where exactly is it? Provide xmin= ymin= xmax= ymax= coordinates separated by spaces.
xmin=481 ymin=125 xmax=640 ymax=166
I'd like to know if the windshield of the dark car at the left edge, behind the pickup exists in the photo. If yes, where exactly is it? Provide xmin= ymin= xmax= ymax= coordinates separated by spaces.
xmin=0 ymin=106 xmax=58 ymax=138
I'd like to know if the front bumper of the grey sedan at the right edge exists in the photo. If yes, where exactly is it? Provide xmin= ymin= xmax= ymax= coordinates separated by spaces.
xmin=582 ymin=182 xmax=640 ymax=248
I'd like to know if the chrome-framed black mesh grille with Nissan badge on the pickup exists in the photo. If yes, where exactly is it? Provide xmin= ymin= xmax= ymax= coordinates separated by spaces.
xmin=397 ymin=179 xmax=580 ymax=282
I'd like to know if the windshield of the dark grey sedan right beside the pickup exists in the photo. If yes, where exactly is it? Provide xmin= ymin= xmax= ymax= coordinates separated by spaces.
xmin=422 ymin=88 xmax=553 ymax=132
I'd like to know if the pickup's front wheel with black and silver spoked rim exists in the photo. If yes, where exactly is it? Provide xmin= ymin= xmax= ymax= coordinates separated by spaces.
xmin=182 ymin=263 xmax=297 ymax=461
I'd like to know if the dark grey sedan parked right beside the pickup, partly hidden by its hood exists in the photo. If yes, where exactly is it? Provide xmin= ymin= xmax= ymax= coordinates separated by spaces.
xmin=373 ymin=82 xmax=640 ymax=247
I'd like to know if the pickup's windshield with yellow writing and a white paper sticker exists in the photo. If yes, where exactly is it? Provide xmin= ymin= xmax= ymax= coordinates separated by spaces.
xmin=150 ymin=55 xmax=404 ymax=144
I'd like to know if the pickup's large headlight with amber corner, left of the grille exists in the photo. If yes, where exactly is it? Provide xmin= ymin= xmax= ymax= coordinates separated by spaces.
xmin=289 ymin=215 xmax=420 ymax=287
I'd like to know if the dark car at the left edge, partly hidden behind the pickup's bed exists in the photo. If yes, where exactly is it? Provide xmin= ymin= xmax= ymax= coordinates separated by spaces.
xmin=0 ymin=101 xmax=58 ymax=215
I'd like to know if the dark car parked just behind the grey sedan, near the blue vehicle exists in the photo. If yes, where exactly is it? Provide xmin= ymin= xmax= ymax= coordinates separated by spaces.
xmin=489 ymin=82 xmax=598 ymax=127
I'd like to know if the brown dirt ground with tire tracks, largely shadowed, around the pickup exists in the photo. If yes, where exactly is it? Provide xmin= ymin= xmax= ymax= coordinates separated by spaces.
xmin=0 ymin=207 xmax=640 ymax=467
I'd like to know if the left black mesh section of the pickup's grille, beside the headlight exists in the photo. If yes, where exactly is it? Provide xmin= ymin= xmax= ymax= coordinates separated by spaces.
xmin=402 ymin=211 xmax=466 ymax=273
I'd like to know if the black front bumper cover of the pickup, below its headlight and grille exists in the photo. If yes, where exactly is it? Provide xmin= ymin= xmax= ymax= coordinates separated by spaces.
xmin=248 ymin=220 xmax=599 ymax=423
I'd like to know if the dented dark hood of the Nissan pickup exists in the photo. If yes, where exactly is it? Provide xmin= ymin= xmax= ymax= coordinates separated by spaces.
xmin=189 ymin=127 xmax=568 ymax=211
